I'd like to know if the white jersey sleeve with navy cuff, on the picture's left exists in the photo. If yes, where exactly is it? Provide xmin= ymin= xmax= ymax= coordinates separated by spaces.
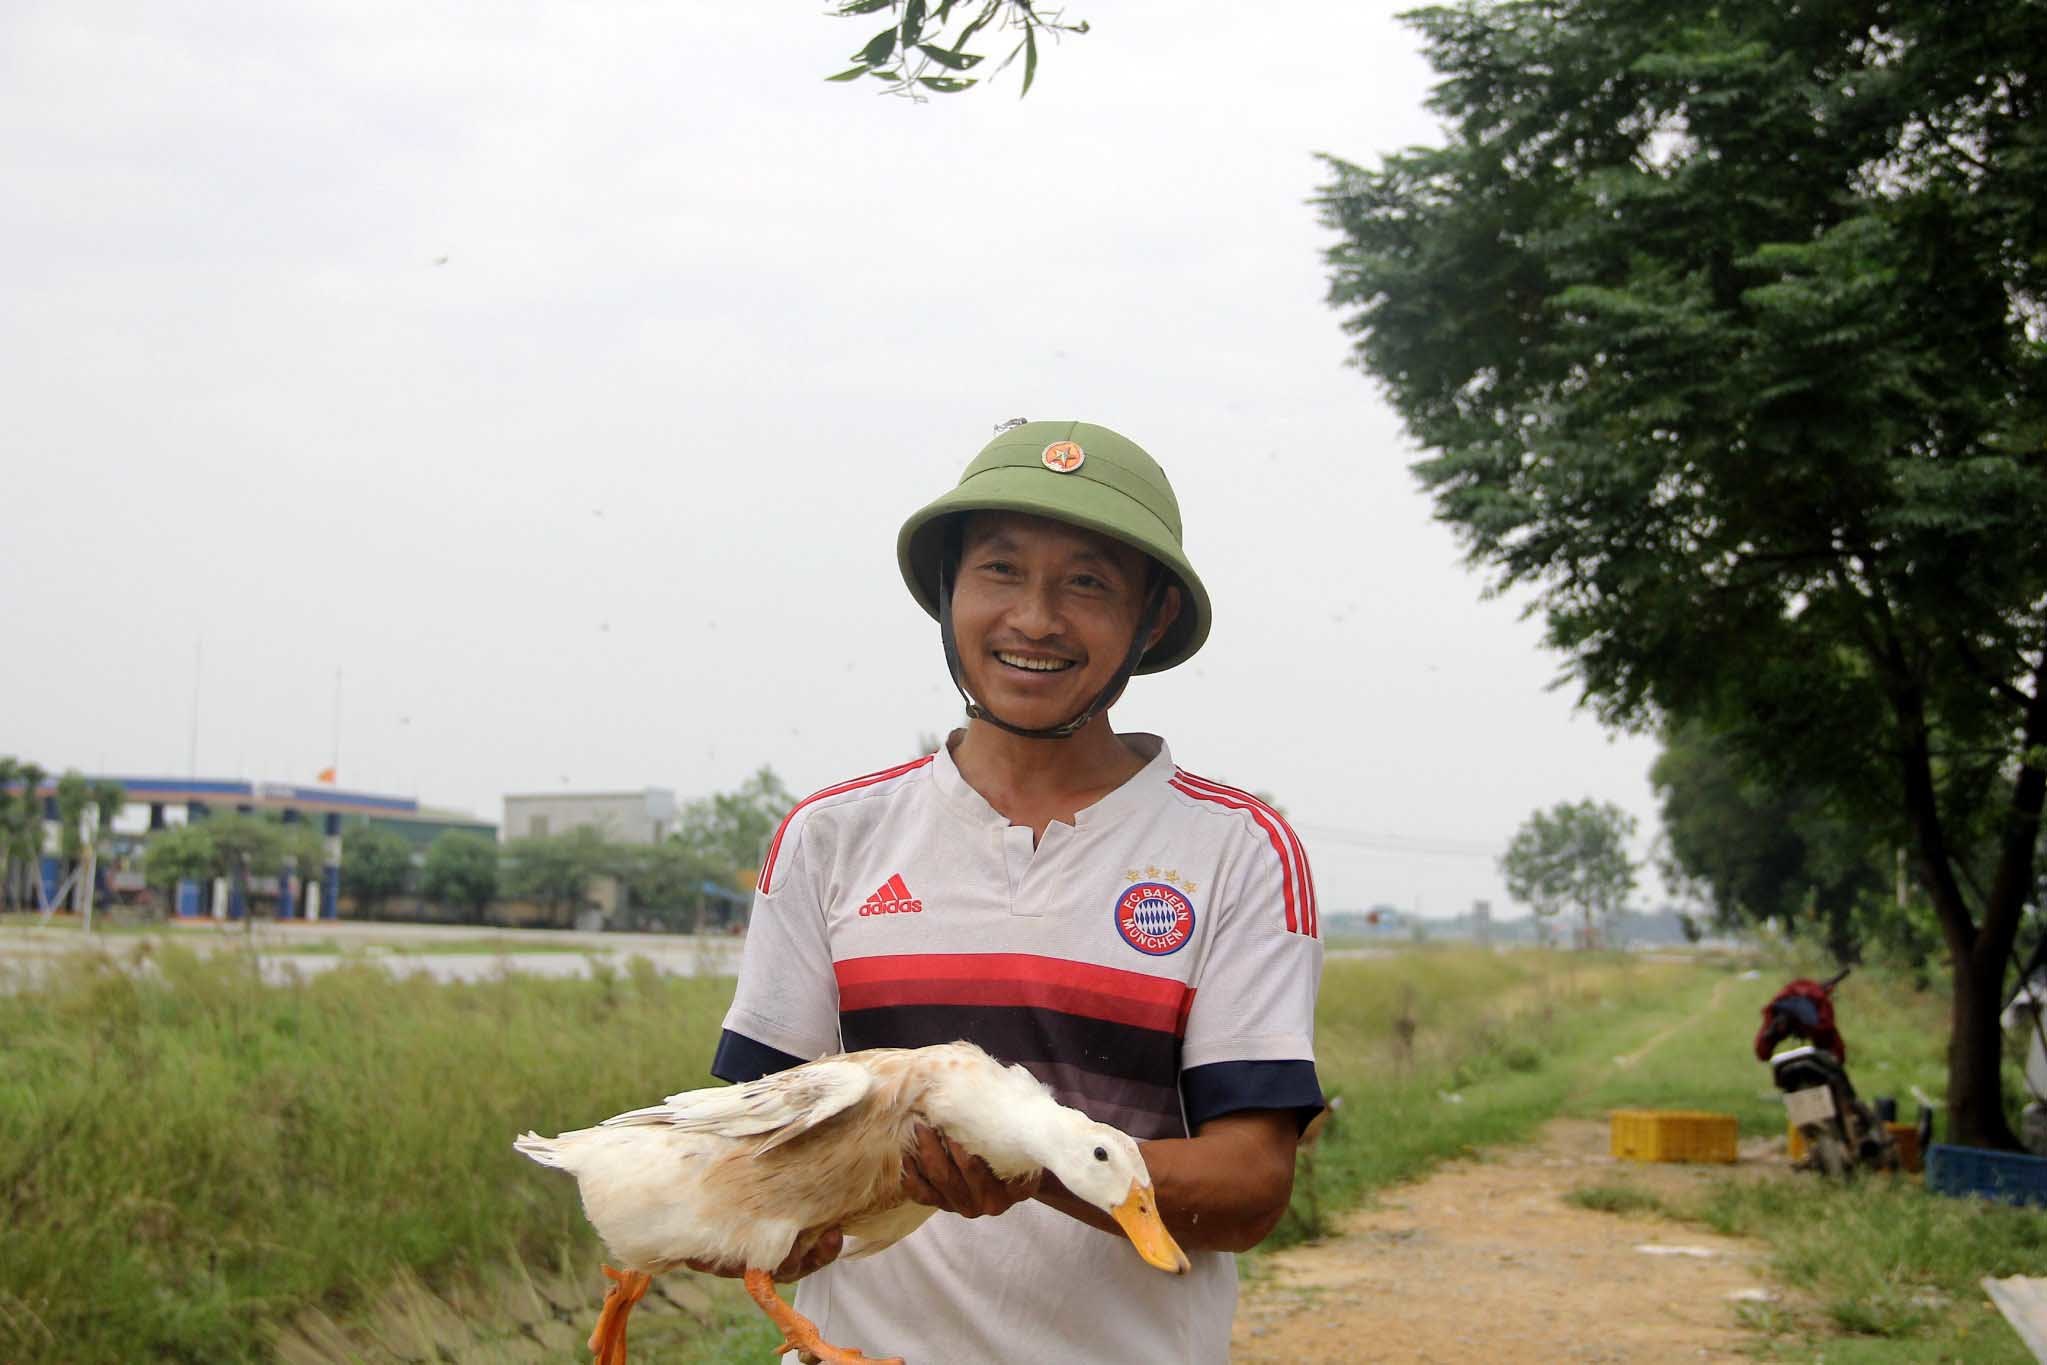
xmin=710 ymin=814 xmax=839 ymax=1083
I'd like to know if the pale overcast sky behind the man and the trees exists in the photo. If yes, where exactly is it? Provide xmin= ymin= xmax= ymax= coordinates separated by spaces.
xmin=0 ymin=0 xmax=1656 ymax=915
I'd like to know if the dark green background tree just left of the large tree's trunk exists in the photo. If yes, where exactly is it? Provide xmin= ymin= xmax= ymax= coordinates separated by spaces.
xmin=1650 ymin=722 xmax=1883 ymax=966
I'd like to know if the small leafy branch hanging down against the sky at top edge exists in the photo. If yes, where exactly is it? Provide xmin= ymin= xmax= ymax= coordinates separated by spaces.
xmin=825 ymin=0 xmax=1087 ymax=98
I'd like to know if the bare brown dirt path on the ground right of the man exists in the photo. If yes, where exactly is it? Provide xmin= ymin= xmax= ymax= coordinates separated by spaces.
xmin=1230 ymin=1119 xmax=1783 ymax=1365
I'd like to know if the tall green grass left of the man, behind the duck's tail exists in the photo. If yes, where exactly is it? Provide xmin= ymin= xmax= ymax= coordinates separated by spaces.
xmin=0 ymin=948 xmax=731 ymax=1363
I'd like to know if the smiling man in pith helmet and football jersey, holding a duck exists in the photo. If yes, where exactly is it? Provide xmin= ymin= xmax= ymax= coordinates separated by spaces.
xmin=712 ymin=422 xmax=1322 ymax=1365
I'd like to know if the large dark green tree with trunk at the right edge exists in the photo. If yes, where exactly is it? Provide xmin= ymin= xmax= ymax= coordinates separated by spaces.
xmin=1322 ymin=0 xmax=2047 ymax=1146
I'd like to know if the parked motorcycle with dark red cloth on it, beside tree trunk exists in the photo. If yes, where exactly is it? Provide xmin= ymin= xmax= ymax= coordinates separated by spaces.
xmin=1756 ymin=968 xmax=1898 ymax=1181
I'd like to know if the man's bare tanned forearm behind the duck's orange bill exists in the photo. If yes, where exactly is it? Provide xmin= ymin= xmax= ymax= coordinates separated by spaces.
xmin=1038 ymin=1111 xmax=1296 ymax=1250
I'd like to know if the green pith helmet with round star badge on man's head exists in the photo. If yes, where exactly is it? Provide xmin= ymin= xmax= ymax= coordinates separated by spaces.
xmin=897 ymin=422 xmax=1210 ymax=673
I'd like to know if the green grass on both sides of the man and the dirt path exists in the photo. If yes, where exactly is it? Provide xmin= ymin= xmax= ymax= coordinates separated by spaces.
xmin=0 ymin=945 xmax=2047 ymax=1365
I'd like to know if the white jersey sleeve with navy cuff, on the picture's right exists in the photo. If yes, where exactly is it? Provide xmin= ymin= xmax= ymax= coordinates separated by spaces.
xmin=1179 ymin=827 xmax=1322 ymax=1132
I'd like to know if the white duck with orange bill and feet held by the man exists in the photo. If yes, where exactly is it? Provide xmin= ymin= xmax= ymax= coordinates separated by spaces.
xmin=514 ymin=1042 xmax=1187 ymax=1365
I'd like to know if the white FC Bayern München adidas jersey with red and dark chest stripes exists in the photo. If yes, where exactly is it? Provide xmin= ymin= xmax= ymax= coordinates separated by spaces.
xmin=716 ymin=735 xmax=1322 ymax=1365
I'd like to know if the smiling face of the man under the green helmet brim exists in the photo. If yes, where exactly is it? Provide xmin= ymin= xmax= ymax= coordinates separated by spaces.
xmin=952 ymin=512 xmax=1179 ymax=731
